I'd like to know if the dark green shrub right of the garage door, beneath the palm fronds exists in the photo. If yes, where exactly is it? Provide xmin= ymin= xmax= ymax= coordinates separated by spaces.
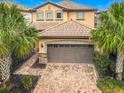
xmin=94 ymin=52 xmax=115 ymax=76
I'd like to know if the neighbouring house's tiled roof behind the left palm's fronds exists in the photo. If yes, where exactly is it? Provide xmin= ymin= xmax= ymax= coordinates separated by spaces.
xmin=1 ymin=1 xmax=31 ymax=10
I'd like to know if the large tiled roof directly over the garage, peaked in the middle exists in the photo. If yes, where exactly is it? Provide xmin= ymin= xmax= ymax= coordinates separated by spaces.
xmin=38 ymin=20 xmax=92 ymax=37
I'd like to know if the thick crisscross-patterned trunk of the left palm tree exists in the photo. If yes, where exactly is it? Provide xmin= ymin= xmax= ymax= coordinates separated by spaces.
xmin=0 ymin=55 xmax=12 ymax=83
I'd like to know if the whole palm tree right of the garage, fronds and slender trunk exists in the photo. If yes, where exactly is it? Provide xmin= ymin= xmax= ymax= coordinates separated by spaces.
xmin=92 ymin=2 xmax=124 ymax=80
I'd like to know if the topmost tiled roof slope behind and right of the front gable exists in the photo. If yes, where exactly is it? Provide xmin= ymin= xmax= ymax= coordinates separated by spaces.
xmin=57 ymin=0 xmax=97 ymax=10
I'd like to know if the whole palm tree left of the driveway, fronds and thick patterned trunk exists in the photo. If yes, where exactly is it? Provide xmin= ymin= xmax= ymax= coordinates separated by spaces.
xmin=0 ymin=3 xmax=37 ymax=81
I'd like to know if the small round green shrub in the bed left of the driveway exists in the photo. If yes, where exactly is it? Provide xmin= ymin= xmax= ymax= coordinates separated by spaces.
xmin=21 ymin=76 xmax=32 ymax=89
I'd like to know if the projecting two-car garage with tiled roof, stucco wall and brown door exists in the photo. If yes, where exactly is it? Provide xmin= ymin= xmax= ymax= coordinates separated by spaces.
xmin=39 ymin=20 xmax=94 ymax=64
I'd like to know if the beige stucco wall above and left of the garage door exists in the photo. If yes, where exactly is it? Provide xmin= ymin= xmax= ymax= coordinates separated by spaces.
xmin=39 ymin=39 xmax=94 ymax=53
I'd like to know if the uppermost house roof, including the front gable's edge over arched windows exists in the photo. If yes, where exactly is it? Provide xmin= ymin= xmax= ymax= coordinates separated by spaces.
xmin=33 ymin=0 xmax=97 ymax=11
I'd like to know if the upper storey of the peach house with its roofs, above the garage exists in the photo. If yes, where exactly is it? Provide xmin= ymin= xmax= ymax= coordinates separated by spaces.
xmin=32 ymin=0 xmax=96 ymax=29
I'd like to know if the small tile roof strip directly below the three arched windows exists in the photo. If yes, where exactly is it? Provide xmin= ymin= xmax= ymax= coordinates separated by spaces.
xmin=31 ymin=22 xmax=62 ymax=30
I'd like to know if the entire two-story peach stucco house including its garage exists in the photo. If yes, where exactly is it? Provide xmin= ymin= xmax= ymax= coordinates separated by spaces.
xmin=1 ymin=0 xmax=97 ymax=64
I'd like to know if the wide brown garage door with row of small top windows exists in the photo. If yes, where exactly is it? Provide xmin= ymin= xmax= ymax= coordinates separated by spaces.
xmin=48 ymin=44 xmax=93 ymax=63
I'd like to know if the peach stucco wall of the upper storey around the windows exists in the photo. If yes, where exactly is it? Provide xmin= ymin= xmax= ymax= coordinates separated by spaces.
xmin=32 ymin=4 xmax=95 ymax=27
